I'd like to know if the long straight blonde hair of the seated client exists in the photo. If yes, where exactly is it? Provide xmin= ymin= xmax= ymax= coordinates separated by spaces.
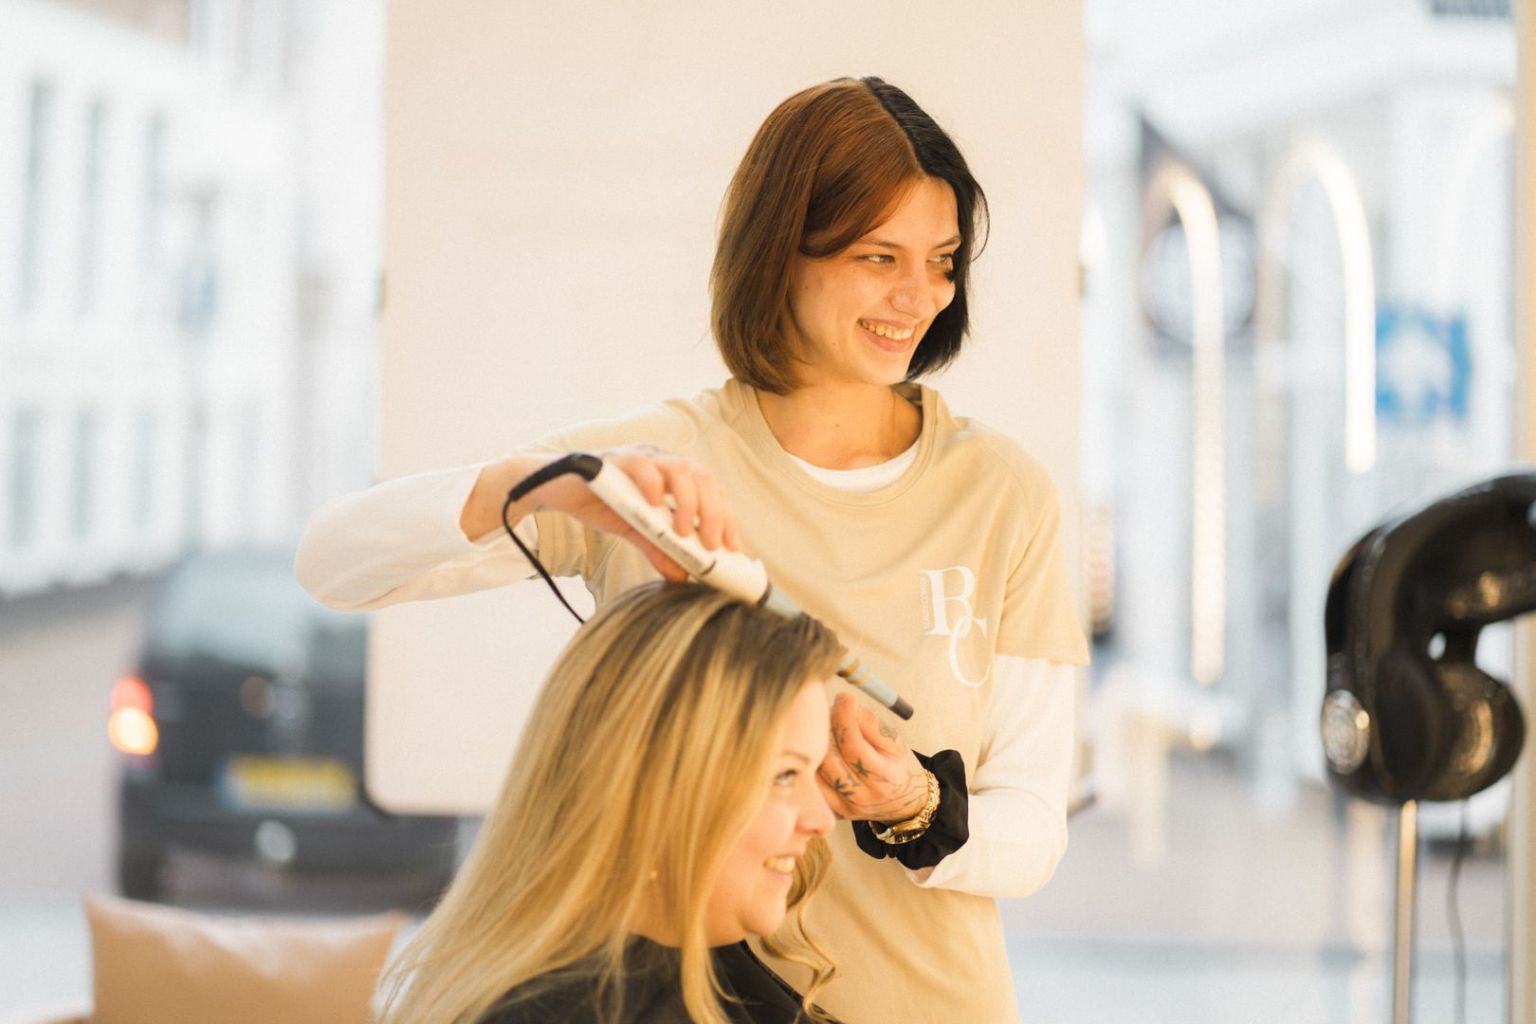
xmin=386 ymin=583 xmax=839 ymax=1024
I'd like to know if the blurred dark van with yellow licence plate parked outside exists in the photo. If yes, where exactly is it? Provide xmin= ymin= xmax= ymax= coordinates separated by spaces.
xmin=109 ymin=550 xmax=458 ymax=900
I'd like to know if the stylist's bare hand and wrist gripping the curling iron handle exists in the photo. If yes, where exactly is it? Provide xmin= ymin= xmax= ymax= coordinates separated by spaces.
xmin=459 ymin=445 xmax=740 ymax=582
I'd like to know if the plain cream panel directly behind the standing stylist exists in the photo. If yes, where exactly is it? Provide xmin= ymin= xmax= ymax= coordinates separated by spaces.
xmin=376 ymin=0 xmax=1083 ymax=811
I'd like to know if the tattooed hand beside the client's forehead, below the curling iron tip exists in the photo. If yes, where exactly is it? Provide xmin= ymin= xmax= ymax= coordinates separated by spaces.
xmin=817 ymin=694 xmax=928 ymax=821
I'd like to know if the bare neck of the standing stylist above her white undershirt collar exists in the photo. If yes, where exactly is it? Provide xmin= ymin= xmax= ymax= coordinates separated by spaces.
xmin=756 ymin=384 xmax=923 ymax=470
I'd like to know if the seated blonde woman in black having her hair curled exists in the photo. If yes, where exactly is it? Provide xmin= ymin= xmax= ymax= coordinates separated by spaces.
xmin=386 ymin=583 xmax=837 ymax=1024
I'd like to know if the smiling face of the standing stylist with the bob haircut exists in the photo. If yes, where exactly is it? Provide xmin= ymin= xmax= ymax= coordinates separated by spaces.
xmin=790 ymin=178 xmax=960 ymax=387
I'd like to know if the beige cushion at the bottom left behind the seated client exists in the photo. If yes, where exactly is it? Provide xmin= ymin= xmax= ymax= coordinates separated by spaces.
xmin=86 ymin=897 xmax=404 ymax=1024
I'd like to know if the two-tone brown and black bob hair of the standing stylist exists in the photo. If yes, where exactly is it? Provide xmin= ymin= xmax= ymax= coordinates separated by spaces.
xmin=710 ymin=78 xmax=986 ymax=395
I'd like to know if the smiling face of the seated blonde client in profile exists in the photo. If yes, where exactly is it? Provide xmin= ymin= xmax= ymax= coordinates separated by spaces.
xmin=705 ymin=682 xmax=834 ymax=946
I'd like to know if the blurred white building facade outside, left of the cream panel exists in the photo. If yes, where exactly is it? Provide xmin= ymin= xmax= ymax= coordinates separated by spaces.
xmin=0 ymin=0 xmax=382 ymax=596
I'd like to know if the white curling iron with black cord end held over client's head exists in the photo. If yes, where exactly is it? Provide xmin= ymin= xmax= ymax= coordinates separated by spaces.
xmin=502 ymin=451 xmax=912 ymax=718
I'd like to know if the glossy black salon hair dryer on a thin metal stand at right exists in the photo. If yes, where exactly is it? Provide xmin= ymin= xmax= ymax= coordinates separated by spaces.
xmin=1321 ymin=473 xmax=1536 ymax=1024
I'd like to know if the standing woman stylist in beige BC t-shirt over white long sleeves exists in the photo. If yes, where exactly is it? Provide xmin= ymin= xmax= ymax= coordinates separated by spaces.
xmin=298 ymin=78 xmax=1086 ymax=1024
